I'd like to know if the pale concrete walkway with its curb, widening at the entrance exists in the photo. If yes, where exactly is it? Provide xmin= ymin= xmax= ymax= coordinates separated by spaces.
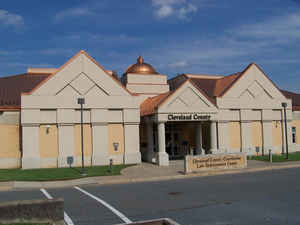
xmin=0 ymin=160 xmax=300 ymax=191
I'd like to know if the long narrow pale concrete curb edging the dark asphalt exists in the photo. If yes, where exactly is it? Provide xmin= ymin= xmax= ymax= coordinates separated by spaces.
xmin=0 ymin=163 xmax=300 ymax=192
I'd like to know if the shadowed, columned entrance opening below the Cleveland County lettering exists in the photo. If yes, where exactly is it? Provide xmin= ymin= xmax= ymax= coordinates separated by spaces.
xmin=146 ymin=118 xmax=217 ymax=166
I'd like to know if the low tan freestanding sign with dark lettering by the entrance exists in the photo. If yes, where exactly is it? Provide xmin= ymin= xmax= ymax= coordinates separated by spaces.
xmin=184 ymin=153 xmax=247 ymax=173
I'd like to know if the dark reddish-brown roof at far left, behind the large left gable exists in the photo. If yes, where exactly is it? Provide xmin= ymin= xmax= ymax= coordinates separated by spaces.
xmin=0 ymin=73 xmax=50 ymax=110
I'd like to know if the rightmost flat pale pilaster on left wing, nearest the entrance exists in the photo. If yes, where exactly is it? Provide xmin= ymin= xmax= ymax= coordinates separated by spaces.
xmin=124 ymin=123 xmax=141 ymax=164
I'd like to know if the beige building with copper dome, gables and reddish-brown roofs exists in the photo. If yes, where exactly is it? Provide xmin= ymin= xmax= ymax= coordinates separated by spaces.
xmin=0 ymin=51 xmax=300 ymax=169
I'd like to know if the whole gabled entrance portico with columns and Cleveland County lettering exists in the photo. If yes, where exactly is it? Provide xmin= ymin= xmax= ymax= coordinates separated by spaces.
xmin=139 ymin=78 xmax=217 ymax=166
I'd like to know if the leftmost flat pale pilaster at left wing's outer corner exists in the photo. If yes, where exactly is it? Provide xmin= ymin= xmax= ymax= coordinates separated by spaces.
xmin=22 ymin=125 xmax=41 ymax=169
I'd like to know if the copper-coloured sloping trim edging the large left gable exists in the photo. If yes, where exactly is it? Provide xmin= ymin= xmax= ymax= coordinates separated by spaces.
xmin=27 ymin=50 xmax=132 ymax=95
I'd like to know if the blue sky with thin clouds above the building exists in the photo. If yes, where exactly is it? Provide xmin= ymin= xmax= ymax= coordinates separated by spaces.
xmin=0 ymin=0 xmax=300 ymax=92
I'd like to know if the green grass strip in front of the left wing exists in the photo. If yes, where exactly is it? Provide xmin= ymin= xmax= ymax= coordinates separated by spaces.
xmin=0 ymin=165 xmax=130 ymax=181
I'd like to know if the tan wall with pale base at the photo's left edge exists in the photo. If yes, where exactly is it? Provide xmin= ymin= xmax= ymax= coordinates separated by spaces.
xmin=0 ymin=124 xmax=21 ymax=168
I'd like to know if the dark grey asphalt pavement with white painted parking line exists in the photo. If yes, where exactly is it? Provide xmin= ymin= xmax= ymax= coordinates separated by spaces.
xmin=0 ymin=168 xmax=300 ymax=225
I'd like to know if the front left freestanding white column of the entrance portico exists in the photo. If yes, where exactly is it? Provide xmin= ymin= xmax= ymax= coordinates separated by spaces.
xmin=158 ymin=122 xmax=169 ymax=166
